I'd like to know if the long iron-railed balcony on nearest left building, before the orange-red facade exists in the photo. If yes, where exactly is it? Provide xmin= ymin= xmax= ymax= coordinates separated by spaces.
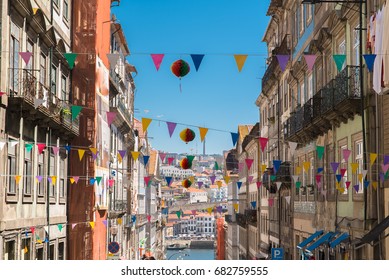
xmin=8 ymin=68 xmax=79 ymax=138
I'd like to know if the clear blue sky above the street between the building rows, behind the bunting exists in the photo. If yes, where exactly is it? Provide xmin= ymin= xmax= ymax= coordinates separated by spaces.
xmin=112 ymin=0 xmax=269 ymax=154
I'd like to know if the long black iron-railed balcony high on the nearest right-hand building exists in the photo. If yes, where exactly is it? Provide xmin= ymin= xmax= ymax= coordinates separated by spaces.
xmin=284 ymin=66 xmax=361 ymax=143
